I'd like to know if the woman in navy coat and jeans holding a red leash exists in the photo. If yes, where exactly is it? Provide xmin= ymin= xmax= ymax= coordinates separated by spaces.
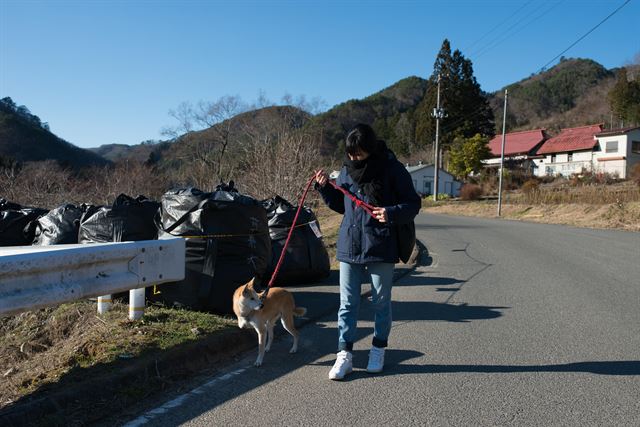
xmin=315 ymin=124 xmax=420 ymax=380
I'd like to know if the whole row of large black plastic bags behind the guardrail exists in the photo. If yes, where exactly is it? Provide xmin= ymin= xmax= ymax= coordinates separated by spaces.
xmin=0 ymin=186 xmax=330 ymax=314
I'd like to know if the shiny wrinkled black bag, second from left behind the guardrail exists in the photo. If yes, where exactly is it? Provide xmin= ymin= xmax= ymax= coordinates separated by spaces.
xmin=33 ymin=204 xmax=88 ymax=246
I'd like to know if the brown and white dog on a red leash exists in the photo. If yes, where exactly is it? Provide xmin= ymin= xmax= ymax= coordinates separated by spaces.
xmin=233 ymin=279 xmax=307 ymax=366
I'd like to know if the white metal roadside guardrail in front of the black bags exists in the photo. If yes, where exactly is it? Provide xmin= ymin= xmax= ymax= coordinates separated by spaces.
xmin=0 ymin=238 xmax=185 ymax=318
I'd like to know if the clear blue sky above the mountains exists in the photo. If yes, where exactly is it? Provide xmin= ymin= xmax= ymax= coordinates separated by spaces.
xmin=0 ymin=0 xmax=640 ymax=147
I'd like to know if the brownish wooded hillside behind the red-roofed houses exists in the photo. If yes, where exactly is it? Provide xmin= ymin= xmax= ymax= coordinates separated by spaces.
xmin=490 ymin=59 xmax=616 ymax=131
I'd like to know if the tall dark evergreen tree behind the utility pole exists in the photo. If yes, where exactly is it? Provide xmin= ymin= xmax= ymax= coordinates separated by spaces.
xmin=416 ymin=39 xmax=494 ymax=151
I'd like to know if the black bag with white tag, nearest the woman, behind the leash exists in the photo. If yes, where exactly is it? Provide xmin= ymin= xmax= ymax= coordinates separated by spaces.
xmin=262 ymin=196 xmax=331 ymax=285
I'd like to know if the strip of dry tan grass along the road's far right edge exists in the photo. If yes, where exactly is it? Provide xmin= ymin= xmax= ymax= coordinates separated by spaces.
xmin=423 ymin=201 xmax=640 ymax=231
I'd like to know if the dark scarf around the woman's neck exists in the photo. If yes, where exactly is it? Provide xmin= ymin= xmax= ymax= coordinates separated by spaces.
xmin=344 ymin=145 xmax=387 ymax=206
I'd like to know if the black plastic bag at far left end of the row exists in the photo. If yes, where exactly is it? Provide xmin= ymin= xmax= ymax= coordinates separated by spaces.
xmin=0 ymin=198 xmax=48 ymax=246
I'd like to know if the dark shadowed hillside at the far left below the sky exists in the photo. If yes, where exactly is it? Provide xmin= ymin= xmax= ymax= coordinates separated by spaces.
xmin=0 ymin=98 xmax=109 ymax=167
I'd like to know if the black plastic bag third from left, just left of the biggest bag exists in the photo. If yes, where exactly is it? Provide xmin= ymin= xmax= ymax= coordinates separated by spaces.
xmin=78 ymin=194 xmax=160 ymax=243
